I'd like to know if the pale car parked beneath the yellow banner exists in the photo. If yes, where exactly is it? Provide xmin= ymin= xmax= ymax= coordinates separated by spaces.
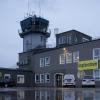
xmin=82 ymin=76 xmax=95 ymax=87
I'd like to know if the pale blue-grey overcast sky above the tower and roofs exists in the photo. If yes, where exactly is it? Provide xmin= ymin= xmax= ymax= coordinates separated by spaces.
xmin=0 ymin=0 xmax=100 ymax=67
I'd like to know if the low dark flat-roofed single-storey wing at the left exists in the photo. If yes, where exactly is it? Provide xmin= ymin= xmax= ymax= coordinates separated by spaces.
xmin=0 ymin=68 xmax=35 ymax=87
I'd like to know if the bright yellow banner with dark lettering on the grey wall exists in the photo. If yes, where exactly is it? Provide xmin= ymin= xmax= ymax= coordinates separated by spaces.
xmin=78 ymin=60 xmax=98 ymax=71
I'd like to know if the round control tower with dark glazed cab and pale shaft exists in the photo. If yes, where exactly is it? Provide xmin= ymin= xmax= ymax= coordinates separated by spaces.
xmin=19 ymin=15 xmax=50 ymax=52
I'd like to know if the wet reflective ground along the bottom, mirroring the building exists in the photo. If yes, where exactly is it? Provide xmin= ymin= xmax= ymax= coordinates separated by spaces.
xmin=0 ymin=88 xmax=100 ymax=100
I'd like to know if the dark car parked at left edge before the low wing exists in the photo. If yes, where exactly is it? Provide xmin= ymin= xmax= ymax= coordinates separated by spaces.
xmin=0 ymin=79 xmax=16 ymax=87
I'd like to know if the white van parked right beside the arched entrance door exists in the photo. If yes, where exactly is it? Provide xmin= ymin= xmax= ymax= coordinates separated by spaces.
xmin=63 ymin=74 xmax=75 ymax=87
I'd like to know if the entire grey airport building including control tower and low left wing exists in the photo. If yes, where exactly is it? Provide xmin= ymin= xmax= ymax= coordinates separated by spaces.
xmin=0 ymin=15 xmax=100 ymax=87
